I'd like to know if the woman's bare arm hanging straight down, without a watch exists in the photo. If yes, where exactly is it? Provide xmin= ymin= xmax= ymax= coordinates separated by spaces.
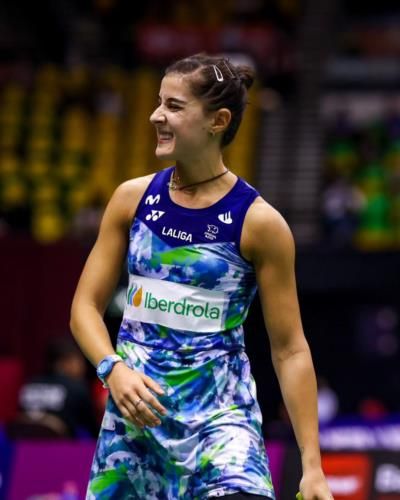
xmin=241 ymin=199 xmax=332 ymax=500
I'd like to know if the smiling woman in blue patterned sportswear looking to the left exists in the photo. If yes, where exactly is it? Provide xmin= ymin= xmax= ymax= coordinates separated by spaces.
xmin=71 ymin=55 xmax=331 ymax=500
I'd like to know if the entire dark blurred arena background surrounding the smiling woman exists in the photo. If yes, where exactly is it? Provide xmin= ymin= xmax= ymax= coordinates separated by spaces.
xmin=0 ymin=0 xmax=400 ymax=500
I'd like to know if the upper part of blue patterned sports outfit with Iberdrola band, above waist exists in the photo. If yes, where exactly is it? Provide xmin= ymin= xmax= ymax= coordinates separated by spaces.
xmin=124 ymin=168 xmax=258 ymax=351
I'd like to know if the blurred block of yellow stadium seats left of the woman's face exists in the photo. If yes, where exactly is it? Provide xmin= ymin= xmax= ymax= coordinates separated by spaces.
xmin=0 ymin=65 xmax=154 ymax=242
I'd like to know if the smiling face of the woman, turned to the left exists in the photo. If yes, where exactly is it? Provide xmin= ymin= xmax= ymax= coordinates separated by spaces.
xmin=150 ymin=73 xmax=212 ymax=163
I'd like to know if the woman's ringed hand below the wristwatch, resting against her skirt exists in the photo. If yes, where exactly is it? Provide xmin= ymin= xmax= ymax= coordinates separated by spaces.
xmin=107 ymin=363 xmax=167 ymax=429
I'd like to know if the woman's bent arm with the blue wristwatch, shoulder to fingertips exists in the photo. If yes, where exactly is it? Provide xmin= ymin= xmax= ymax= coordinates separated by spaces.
xmin=70 ymin=177 xmax=165 ymax=427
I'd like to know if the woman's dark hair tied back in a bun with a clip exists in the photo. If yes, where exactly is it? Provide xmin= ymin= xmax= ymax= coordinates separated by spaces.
xmin=165 ymin=53 xmax=254 ymax=146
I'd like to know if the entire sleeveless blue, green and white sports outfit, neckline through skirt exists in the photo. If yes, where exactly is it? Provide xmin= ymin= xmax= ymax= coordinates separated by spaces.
xmin=87 ymin=168 xmax=274 ymax=500
